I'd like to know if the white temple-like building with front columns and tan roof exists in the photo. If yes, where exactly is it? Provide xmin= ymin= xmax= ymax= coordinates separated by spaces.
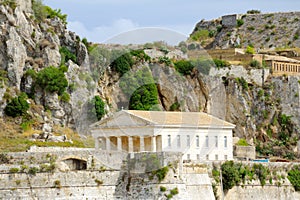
xmin=91 ymin=110 xmax=235 ymax=161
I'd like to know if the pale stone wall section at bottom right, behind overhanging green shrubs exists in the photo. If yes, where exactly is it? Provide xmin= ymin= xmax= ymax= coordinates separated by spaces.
xmin=208 ymin=161 xmax=300 ymax=200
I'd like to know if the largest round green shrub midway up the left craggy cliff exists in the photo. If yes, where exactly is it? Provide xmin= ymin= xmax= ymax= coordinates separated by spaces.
xmin=36 ymin=66 xmax=68 ymax=95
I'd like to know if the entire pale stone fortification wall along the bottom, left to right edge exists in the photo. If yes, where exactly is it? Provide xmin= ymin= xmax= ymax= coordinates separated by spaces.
xmin=0 ymin=150 xmax=300 ymax=200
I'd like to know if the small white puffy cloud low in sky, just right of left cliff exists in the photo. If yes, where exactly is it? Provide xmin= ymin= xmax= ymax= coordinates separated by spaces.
xmin=68 ymin=19 xmax=139 ymax=42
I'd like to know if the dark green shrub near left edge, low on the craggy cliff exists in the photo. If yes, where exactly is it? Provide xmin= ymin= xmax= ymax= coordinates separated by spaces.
xmin=4 ymin=93 xmax=30 ymax=117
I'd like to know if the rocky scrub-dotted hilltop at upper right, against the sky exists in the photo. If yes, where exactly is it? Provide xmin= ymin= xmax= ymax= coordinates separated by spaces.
xmin=191 ymin=12 xmax=300 ymax=49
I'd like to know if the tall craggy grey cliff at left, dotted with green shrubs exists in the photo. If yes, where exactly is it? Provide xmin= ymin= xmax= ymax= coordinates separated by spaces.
xmin=0 ymin=0 xmax=95 ymax=141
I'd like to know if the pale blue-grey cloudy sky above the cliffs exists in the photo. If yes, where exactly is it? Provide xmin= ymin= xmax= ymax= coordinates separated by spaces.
xmin=43 ymin=0 xmax=300 ymax=43
